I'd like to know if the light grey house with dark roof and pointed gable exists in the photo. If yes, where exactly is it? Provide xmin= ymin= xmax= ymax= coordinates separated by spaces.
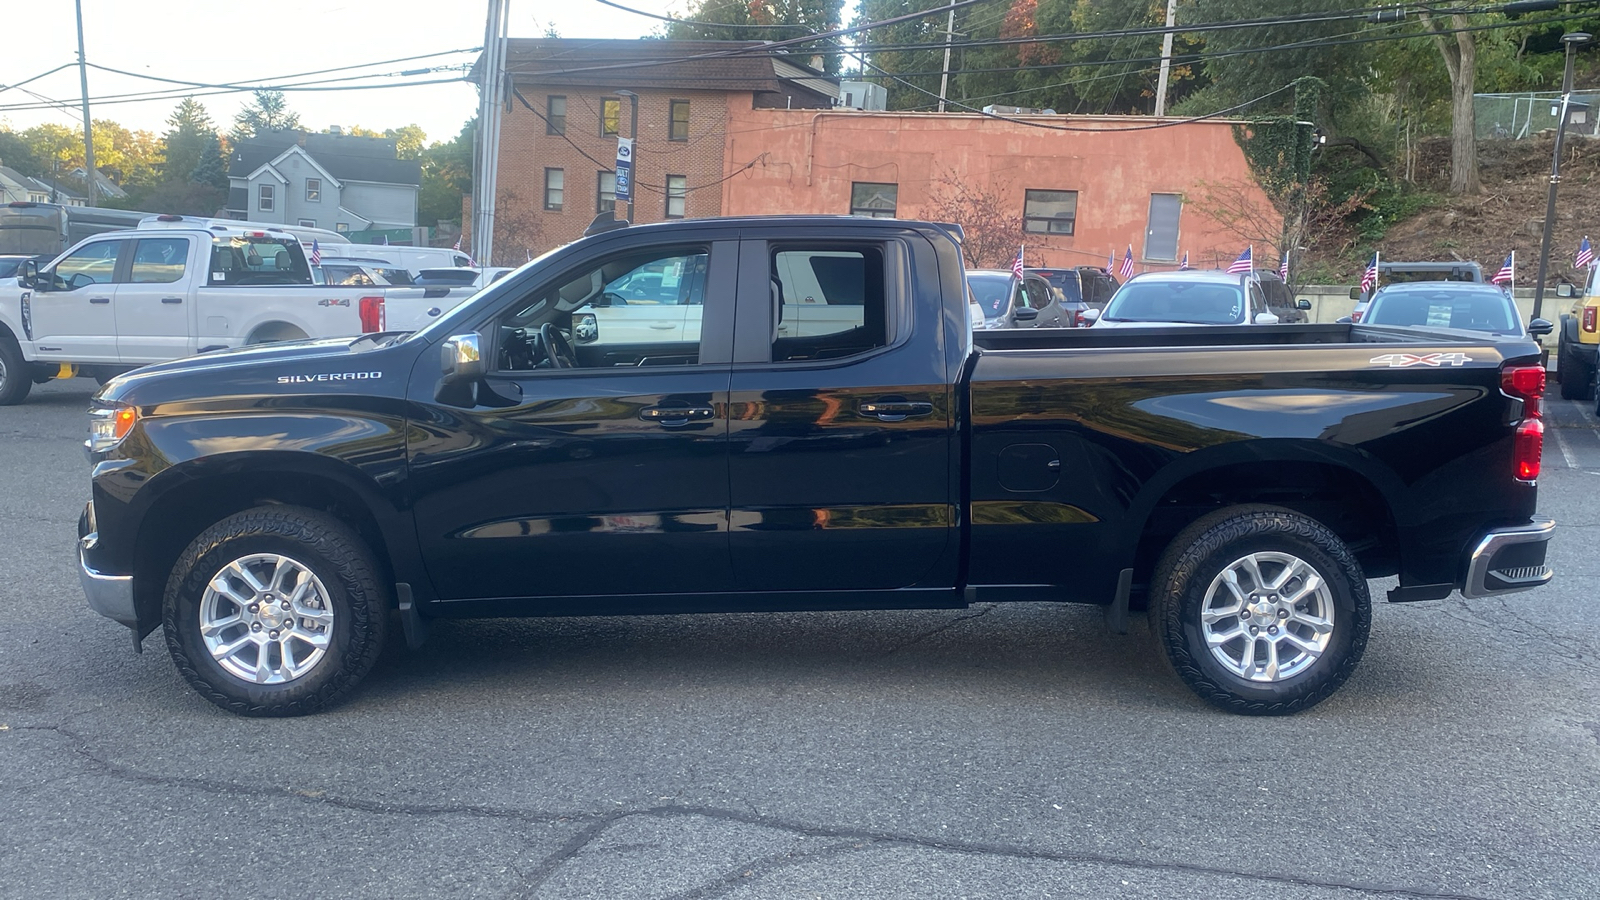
xmin=227 ymin=131 xmax=422 ymax=232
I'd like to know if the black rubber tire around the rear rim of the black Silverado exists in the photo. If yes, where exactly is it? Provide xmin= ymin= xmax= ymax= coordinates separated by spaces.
xmin=1149 ymin=506 xmax=1373 ymax=716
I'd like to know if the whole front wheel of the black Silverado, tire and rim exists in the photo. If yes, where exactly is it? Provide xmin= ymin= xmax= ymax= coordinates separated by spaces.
xmin=162 ymin=506 xmax=389 ymax=716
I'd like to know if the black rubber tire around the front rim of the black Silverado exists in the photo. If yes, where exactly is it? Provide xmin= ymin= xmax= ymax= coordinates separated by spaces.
xmin=162 ymin=506 xmax=389 ymax=716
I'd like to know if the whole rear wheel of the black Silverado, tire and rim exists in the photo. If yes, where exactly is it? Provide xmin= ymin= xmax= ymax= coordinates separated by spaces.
xmin=1149 ymin=506 xmax=1373 ymax=716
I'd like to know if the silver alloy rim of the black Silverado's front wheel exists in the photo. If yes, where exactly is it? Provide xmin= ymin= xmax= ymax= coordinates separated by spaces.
xmin=200 ymin=552 xmax=333 ymax=684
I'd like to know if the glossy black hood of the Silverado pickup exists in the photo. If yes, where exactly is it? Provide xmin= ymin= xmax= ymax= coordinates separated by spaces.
xmin=98 ymin=333 xmax=408 ymax=400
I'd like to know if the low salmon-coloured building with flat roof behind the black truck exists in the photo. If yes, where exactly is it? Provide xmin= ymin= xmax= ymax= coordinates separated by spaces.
xmin=722 ymin=109 xmax=1277 ymax=271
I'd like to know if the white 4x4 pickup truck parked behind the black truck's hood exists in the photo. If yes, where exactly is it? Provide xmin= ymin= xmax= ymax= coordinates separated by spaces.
xmin=0 ymin=226 xmax=474 ymax=405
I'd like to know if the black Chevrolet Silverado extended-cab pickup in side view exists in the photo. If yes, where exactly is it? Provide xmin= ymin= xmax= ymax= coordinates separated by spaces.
xmin=80 ymin=218 xmax=1552 ymax=716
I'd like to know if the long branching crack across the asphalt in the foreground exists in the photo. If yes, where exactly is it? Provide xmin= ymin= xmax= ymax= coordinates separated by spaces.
xmin=11 ymin=717 xmax=1510 ymax=900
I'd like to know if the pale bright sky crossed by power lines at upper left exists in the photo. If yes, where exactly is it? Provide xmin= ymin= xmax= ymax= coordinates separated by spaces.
xmin=0 ymin=0 xmax=700 ymax=150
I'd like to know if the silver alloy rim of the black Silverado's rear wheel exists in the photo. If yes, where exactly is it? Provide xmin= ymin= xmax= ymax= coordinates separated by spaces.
xmin=1200 ymin=551 xmax=1333 ymax=682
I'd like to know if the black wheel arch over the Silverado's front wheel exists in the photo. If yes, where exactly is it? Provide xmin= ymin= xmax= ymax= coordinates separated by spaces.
xmin=133 ymin=455 xmax=405 ymax=637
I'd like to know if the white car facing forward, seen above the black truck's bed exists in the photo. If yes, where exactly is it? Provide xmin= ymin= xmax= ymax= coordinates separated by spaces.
xmin=1085 ymin=269 xmax=1278 ymax=328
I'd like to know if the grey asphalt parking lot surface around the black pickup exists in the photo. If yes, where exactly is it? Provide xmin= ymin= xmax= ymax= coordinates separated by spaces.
xmin=0 ymin=380 xmax=1600 ymax=900
